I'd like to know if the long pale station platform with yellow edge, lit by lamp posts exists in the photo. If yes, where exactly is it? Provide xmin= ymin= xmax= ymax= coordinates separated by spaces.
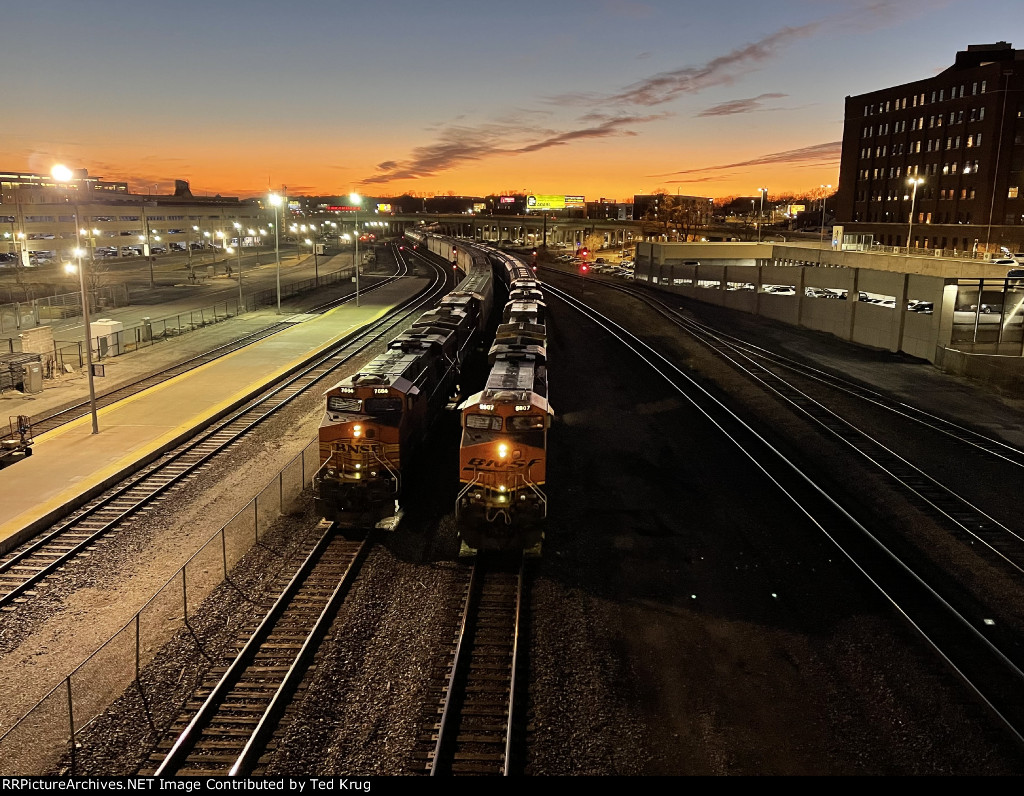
xmin=0 ymin=279 xmax=423 ymax=552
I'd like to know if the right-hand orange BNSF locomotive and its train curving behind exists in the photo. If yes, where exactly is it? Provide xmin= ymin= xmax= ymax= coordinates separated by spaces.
xmin=456 ymin=246 xmax=553 ymax=552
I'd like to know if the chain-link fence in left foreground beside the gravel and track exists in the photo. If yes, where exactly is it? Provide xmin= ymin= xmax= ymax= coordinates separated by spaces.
xmin=0 ymin=439 xmax=319 ymax=777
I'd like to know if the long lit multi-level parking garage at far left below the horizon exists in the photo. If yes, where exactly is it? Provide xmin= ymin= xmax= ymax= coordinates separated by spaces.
xmin=0 ymin=169 xmax=264 ymax=265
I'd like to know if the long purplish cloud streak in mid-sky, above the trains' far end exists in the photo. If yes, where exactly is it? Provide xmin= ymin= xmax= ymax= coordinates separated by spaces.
xmin=361 ymin=115 xmax=663 ymax=185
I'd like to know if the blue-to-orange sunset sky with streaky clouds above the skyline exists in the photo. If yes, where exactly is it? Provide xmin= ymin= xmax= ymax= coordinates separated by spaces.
xmin=6 ymin=0 xmax=1024 ymax=201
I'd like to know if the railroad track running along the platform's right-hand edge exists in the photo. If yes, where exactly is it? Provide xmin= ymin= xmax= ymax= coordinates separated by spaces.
xmin=0 ymin=255 xmax=446 ymax=611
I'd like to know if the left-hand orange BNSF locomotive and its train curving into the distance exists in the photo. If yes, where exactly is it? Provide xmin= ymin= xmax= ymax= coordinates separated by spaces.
xmin=314 ymin=234 xmax=495 ymax=528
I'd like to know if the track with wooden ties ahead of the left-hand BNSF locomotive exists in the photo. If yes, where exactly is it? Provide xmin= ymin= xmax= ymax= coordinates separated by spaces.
xmin=144 ymin=528 xmax=370 ymax=777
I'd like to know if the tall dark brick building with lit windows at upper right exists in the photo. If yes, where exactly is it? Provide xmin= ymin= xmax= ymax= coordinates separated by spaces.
xmin=836 ymin=42 xmax=1024 ymax=252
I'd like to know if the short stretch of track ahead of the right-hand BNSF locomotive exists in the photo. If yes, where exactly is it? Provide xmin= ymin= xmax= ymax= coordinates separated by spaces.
xmin=424 ymin=556 xmax=524 ymax=776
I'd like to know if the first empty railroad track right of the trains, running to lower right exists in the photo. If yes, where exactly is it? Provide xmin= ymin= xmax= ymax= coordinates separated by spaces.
xmin=545 ymin=284 xmax=1024 ymax=746
